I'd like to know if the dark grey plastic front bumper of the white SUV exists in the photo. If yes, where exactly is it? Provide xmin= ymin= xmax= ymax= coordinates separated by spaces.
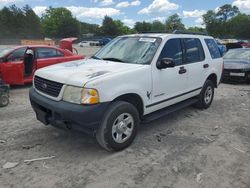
xmin=29 ymin=88 xmax=109 ymax=132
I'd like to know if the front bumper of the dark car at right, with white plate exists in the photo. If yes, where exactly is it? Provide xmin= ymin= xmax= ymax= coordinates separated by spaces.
xmin=222 ymin=69 xmax=250 ymax=82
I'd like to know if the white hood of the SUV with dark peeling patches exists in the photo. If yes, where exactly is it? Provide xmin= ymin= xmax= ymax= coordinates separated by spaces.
xmin=35 ymin=59 xmax=143 ymax=87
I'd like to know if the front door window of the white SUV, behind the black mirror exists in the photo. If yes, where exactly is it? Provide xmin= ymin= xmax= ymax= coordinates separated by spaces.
xmin=158 ymin=38 xmax=183 ymax=66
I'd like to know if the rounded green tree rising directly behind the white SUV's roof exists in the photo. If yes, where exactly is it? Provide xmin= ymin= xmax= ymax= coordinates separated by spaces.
xmin=166 ymin=14 xmax=185 ymax=33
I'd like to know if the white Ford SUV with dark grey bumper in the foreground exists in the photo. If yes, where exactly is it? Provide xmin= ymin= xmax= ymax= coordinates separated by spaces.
xmin=30 ymin=34 xmax=223 ymax=151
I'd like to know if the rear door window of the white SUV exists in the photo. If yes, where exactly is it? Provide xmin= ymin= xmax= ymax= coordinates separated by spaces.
xmin=183 ymin=38 xmax=205 ymax=63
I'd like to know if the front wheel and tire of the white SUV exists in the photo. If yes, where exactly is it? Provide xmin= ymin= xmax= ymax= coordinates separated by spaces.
xmin=96 ymin=101 xmax=140 ymax=151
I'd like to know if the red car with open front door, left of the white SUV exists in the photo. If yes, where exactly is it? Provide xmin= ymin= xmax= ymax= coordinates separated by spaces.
xmin=0 ymin=41 xmax=84 ymax=85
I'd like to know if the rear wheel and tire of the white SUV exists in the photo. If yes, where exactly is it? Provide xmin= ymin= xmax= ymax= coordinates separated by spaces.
xmin=195 ymin=80 xmax=214 ymax=109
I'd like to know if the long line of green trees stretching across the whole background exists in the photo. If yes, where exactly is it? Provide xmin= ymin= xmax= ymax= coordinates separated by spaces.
xmin=0 ymin=4 xmax=250 ymax=38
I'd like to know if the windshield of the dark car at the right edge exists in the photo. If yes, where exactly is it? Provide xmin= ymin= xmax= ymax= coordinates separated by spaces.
xmin=224 ymin=49 xmax=250 ymax=61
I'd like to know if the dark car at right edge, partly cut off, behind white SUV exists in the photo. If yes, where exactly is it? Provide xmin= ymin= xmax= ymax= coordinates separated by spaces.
xmin=222 ymin=48 xmax=250 ymax=82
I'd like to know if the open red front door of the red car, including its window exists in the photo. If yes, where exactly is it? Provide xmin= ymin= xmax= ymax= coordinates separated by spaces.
xmin=1 ymin=47 xmax=27 ymax=85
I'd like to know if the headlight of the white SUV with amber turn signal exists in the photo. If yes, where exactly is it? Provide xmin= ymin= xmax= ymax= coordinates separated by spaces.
xmin=63 ymin=86 xmax=99 ymax=104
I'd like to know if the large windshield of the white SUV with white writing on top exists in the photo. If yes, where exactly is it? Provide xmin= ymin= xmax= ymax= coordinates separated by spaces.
xmin=93 ymin=37 xmax=161 ymax=64
